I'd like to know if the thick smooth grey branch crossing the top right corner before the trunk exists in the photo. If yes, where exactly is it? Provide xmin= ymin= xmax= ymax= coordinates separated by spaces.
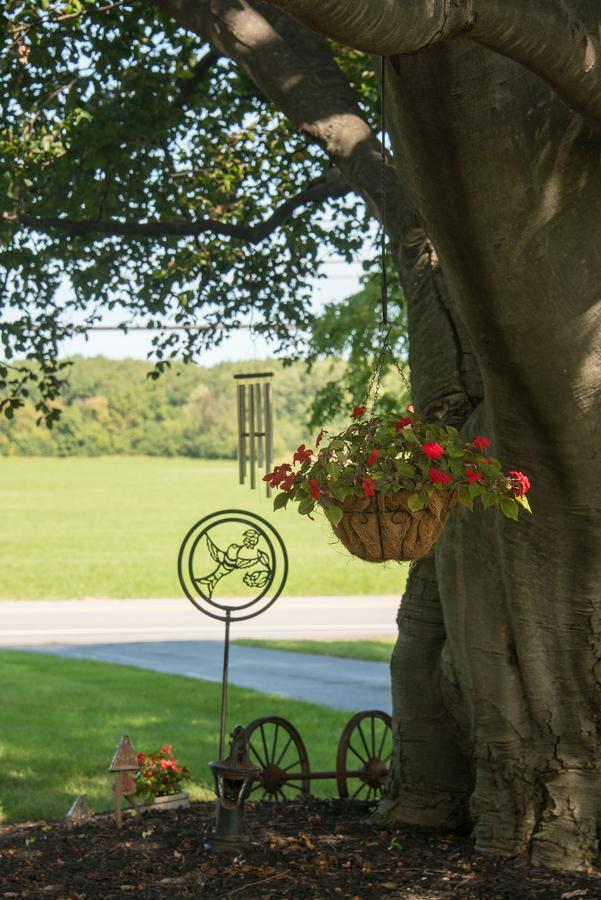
xmin=266 ymin=0 xmax=601 ymax=125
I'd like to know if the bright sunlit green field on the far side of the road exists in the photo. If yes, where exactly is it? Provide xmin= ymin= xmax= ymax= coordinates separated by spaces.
xmin=0 ymin=457 xmax=407 ymax=599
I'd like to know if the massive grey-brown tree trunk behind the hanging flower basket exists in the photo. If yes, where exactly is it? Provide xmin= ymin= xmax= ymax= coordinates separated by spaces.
xmin=262 ymin=0 xmax=601 ymax=868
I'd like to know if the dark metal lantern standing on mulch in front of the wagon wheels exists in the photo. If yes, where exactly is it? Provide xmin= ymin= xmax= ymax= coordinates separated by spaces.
xmin=206 ymin=725 xmax=261 ymax=853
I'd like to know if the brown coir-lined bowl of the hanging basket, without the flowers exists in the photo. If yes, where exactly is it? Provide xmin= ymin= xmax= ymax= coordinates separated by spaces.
xmin=334 ymin=491 xmax=457 ymax=562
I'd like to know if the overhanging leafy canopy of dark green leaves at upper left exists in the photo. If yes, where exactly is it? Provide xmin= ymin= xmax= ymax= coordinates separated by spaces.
xmin=0 ymin=0 xmax=404 ymax=421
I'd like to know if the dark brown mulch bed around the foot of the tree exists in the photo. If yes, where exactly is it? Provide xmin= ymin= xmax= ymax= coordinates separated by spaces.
xmin=0 ymin=800 xmax=601 ymax=900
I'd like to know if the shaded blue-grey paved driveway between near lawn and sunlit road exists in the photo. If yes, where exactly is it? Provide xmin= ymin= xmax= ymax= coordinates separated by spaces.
xmin=27 ymin=641 xmax=390 ymax=712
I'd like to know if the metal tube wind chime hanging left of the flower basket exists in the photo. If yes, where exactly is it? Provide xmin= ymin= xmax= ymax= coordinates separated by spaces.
xmin=234 ymin=372 xmax=273 ymax=497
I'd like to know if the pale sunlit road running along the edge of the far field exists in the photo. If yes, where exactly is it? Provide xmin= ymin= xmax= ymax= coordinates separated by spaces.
xmin=0 ymin=596 xmax=399 ymax=647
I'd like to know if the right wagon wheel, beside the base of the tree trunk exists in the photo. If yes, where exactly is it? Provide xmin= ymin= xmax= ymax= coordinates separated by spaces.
xmin=336 ymin=710 xmax=392 ymax=800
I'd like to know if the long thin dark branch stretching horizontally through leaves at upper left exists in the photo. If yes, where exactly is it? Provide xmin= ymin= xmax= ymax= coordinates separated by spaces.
xmin=2 ymin=172 xmax=351 ymax=244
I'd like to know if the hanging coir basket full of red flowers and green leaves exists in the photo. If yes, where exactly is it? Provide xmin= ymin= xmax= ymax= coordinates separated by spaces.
xmin=265 ymin=406 xmax=530 ymax=562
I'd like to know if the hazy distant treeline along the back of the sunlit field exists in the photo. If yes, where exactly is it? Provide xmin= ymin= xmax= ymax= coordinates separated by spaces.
xmin=0 ymin=357 xmax=343 ymax=459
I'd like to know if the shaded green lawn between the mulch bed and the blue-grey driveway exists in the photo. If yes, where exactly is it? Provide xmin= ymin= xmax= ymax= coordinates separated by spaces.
xmin=0 ymin=650 xmax=350 ymax=822
